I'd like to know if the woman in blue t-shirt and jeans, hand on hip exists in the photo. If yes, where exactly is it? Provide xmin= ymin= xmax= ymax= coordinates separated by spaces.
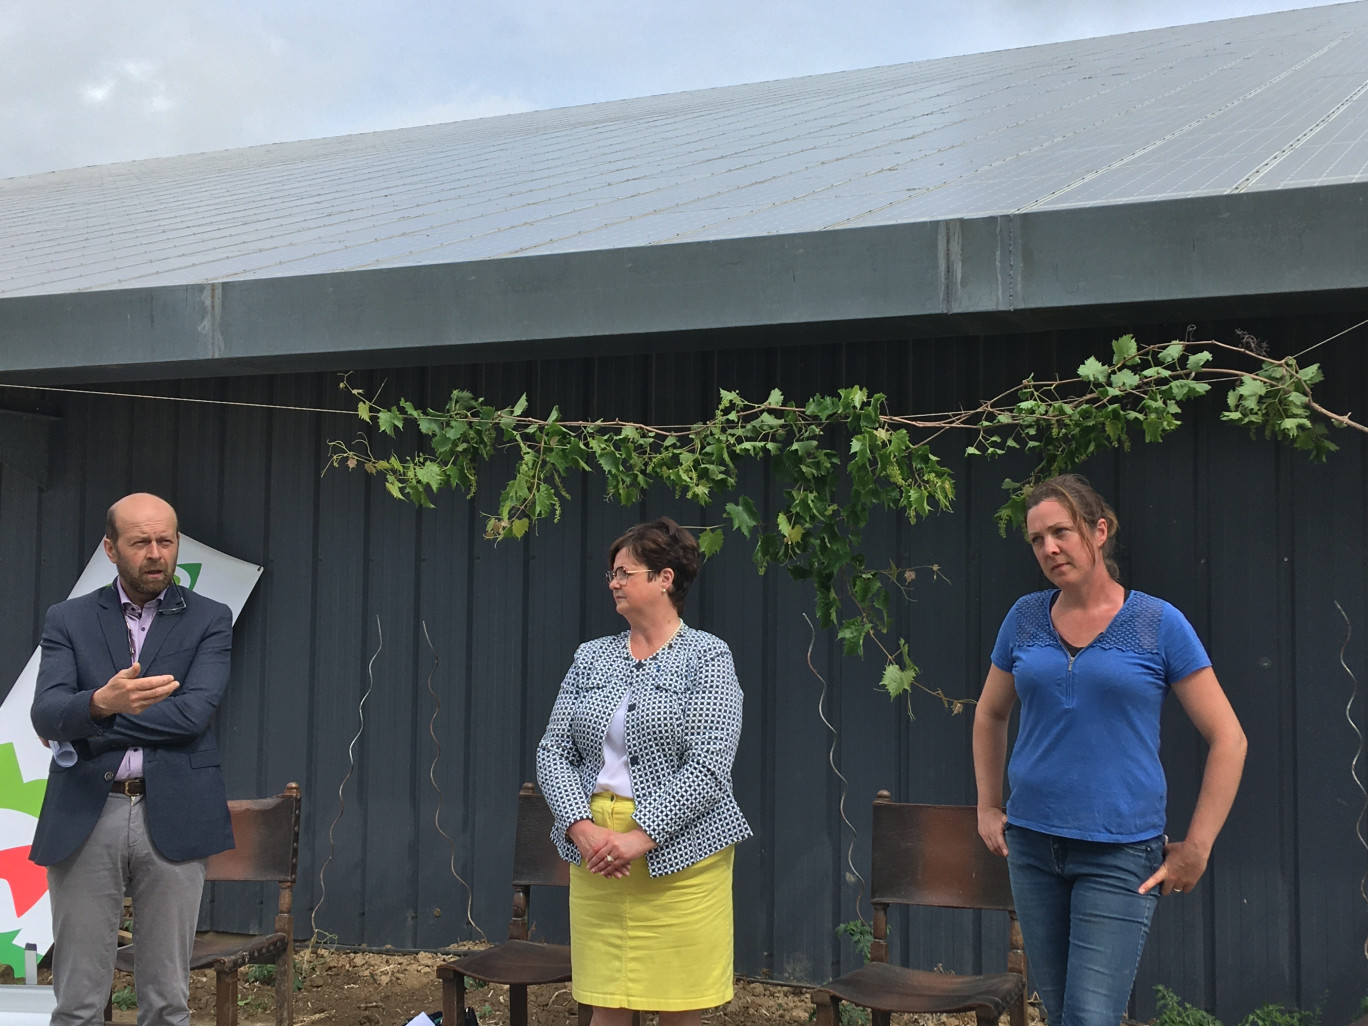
xmin=974 ymin=475 xmax=1245 ymax=1026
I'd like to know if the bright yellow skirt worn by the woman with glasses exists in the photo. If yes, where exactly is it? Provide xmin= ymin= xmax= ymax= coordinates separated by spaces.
xmin=570 ymin=793 xmax=735 ymax=1012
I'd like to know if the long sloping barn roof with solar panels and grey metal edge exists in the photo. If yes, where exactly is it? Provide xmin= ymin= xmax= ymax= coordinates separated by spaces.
xmin=0 ymin=0 xmax=1368 ymax=379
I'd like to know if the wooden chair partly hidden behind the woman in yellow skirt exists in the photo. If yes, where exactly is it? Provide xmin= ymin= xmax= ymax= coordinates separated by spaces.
xmin=436 ymin=784 xmax=591 ymax=1026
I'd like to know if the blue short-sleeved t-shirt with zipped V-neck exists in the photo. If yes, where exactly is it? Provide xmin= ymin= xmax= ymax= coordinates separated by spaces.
xmin=993 ymin=590 xmax=1211 ymax=844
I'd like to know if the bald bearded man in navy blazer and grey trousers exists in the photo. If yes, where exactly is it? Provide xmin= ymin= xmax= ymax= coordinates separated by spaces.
xmin=29 ymin=492 xmax=233 ymax=1026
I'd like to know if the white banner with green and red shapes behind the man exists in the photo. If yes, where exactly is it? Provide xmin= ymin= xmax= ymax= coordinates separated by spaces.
xmin=0 ymin=535 xmax=261 ymax=977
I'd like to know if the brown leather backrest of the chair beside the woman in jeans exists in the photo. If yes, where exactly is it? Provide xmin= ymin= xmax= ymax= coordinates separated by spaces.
xmin=870 ymin=791 xmax=1015 ymax=911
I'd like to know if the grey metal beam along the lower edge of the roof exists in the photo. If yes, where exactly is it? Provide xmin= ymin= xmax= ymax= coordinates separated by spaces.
xmin=0 ymin=183 xmax=1368 ymax=382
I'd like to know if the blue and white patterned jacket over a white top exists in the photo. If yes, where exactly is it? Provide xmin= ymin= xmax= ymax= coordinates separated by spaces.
xmin=536 ymin=625 xmax=751 ymax=877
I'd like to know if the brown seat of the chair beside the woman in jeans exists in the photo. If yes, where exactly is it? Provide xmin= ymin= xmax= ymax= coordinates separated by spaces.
xmin=813 ymin=962 xmax=1026 ymax=1016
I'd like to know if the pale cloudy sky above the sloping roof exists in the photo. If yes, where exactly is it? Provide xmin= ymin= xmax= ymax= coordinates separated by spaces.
xmin=0 ymin=0 xmax=1346 ymax=178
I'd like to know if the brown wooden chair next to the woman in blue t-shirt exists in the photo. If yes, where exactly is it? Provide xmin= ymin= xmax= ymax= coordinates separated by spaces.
xmin=811 ymin=791 xmax=1026 ymax=1026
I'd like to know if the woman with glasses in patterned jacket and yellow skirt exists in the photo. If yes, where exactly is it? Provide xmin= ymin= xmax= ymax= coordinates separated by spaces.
xmin=536 ymin=517 xmax=751 ymax=1026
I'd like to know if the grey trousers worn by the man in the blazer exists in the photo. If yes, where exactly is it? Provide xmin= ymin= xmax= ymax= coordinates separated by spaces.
xmin=48 ymin=795 xmax=205 ymax=1026
